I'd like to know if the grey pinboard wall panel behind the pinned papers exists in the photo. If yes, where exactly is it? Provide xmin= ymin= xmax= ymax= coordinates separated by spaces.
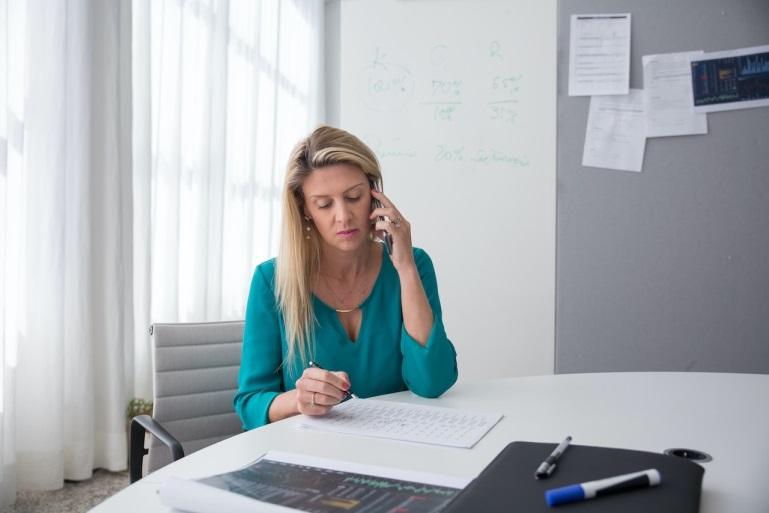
xmin=555 ymin=0 xmax=769 ymax=373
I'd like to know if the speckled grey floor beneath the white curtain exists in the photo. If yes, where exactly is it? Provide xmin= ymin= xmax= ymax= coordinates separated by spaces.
xmin=2 ymin=470 xmax=128 ymax=513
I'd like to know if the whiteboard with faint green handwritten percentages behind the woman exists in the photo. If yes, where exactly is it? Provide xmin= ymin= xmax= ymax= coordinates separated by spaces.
xmin=340 ymin=0 xmax=556 ymax=380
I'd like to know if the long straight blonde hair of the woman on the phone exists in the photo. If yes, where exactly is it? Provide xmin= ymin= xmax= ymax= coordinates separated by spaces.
xmin=275 ymin=126 xmax=382 ymax=365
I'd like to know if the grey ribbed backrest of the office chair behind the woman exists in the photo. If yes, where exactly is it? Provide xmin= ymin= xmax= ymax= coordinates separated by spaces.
xmin=147 ymin=321 xmax=244 ymax=472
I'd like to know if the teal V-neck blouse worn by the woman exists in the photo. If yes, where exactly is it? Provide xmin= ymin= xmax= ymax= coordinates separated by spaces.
xmin=235 ymin=248 xmax=457 ymax=429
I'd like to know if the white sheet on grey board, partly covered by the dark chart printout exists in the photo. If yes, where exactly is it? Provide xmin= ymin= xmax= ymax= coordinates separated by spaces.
xmin=643 ymin=51 xmax=708 ymax=137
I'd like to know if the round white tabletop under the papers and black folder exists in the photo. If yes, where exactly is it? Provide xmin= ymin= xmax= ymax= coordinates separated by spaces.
xmin=92 ymin=372 xmax=769 ymax=513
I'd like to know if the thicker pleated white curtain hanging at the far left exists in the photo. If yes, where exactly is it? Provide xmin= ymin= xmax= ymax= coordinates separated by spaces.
xmin=0 ymin=0 xmax=134 ymax=505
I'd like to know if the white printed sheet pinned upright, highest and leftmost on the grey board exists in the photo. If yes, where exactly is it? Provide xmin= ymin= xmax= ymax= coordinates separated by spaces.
xmin=569 ymin=13 xmax=630 ymax=96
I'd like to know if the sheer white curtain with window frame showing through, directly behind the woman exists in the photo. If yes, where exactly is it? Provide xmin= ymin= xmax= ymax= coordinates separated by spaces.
xmin=133 ymin=0 xmax=324 ymax=398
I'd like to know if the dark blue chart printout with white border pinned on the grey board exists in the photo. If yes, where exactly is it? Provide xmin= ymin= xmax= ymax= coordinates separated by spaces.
xmin=691 ymin=45 xmax=769 ymax=112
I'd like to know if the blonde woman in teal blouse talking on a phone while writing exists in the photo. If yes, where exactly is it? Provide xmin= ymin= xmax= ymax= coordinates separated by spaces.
xmin=235 ymin=126 xmax=457 ymax=429
